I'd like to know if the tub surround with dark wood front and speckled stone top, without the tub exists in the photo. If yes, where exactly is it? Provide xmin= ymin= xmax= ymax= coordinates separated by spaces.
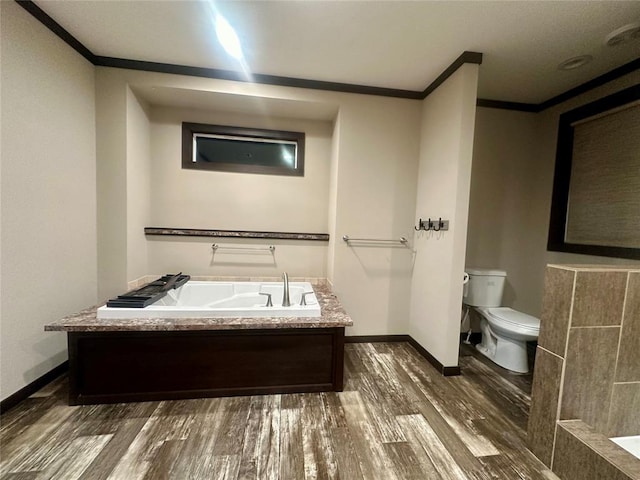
xmin=45 ymin=285 xmax=353 ymax=405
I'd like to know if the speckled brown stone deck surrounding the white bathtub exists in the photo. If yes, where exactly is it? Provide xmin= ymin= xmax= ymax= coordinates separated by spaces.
xmin=44 ymin=285 xmax=353 ymax=332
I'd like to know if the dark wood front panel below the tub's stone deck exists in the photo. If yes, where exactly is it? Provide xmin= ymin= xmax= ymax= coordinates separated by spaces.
xmin=69 ymin=328 xmax=344 ymax=404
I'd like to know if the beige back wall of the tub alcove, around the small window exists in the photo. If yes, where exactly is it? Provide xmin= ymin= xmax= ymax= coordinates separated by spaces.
xmin=148 ymin=107 xmax=333 ymax=277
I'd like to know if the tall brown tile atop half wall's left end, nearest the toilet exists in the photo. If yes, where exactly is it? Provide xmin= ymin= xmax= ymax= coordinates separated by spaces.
xmin=538 ymin=267 xmax=576 ymax=357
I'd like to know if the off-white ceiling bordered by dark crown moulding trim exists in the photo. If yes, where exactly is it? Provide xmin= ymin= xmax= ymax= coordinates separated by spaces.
xmin=35 ymin=0 xmax=640 ymax=104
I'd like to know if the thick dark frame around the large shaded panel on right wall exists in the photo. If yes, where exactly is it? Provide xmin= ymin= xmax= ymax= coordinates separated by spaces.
xmin=547 ymin=85 xmax=640 ymax=260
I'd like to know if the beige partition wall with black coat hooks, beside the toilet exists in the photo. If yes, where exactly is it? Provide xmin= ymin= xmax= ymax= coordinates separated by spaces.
xmin=409 ymin=64 xmax=478 ymax=366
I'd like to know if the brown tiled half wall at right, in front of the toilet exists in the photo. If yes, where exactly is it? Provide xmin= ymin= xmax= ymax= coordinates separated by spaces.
xmin=528 ymin=265 xmax=640 ymax=478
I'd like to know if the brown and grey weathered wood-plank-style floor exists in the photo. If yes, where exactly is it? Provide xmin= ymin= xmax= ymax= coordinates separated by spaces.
xmin=0 ymin=343 xmax=555 ymax=480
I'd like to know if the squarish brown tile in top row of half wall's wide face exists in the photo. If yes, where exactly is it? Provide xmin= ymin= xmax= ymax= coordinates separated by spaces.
xmin=571 ymin=271 xmax=627 ymax=327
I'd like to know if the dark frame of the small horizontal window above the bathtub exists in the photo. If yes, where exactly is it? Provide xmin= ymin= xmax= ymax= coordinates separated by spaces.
xmin=182 ymin=122 xmax=305 ymax=177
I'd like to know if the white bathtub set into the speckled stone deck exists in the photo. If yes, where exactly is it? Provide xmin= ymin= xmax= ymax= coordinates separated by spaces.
xmin=98 ymin=281 xmax=320 ymax=319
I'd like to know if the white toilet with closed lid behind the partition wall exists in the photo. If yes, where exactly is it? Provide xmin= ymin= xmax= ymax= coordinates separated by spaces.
xmin=462 ymin=268 xmax=540 ymax=373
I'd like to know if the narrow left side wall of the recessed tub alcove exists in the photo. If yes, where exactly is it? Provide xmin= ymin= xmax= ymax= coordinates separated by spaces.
xmin=126 ymin=87 xmax=153 ymax=280
